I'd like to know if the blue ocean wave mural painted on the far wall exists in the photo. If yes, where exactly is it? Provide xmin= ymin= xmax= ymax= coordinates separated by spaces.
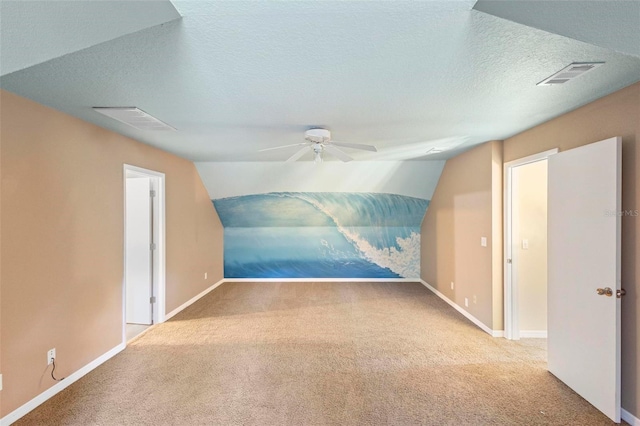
xmin=213 ymin=192 xmax=429 ymax=278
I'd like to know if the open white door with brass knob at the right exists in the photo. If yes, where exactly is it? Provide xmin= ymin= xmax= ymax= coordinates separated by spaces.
xmin=548 ymin=138 xmax=621 ymax=422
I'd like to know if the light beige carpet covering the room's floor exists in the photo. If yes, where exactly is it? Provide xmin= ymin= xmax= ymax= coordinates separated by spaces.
xmin=17 ymin=283 xmax=612 ymax=426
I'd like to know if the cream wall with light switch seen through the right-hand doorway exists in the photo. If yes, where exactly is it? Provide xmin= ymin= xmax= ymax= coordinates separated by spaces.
xmin=511 ymin=160 xmax=547 ymax=331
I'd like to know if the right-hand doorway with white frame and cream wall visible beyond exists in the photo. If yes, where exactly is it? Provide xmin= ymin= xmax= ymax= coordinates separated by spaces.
xmin=504 ymin=149 xmax=558 ymax=340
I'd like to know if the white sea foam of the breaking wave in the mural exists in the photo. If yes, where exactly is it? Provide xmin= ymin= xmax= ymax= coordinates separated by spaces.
xmin=292 ymin=194 xmax=420 ymax=278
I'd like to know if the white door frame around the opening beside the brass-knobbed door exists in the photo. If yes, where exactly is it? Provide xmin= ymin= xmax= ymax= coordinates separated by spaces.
xmin=503 ymin=148 xmax=558 ymax=340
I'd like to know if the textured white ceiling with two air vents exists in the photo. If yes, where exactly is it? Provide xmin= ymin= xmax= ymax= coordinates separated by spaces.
xmin=0 ymin=0 xmax=640 ymax=161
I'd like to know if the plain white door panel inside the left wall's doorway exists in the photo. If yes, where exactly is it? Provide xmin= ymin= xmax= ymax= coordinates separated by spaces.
xmin=125 ymin=177 xmax=153 ymax=324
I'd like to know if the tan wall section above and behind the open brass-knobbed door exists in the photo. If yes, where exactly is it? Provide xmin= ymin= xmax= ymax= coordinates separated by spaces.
xmin=504 ymin=83 xmax=640 ymax=417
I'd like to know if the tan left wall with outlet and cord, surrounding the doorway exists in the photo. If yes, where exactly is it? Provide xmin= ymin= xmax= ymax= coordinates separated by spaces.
xmin=0 ymin=91 xmax=223 ymax=416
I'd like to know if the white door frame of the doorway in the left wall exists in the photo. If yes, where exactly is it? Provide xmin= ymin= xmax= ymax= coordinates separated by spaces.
xmin=122 ymin=163 xmax=166 ymax=344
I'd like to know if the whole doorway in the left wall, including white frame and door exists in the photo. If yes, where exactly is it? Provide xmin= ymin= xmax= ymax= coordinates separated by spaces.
xmin=122 ymin=164 xmax=165 ymax=344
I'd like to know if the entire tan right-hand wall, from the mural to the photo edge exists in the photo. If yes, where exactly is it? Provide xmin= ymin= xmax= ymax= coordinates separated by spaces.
xmin=421 ymin=83 xmax=640 ymax=417
